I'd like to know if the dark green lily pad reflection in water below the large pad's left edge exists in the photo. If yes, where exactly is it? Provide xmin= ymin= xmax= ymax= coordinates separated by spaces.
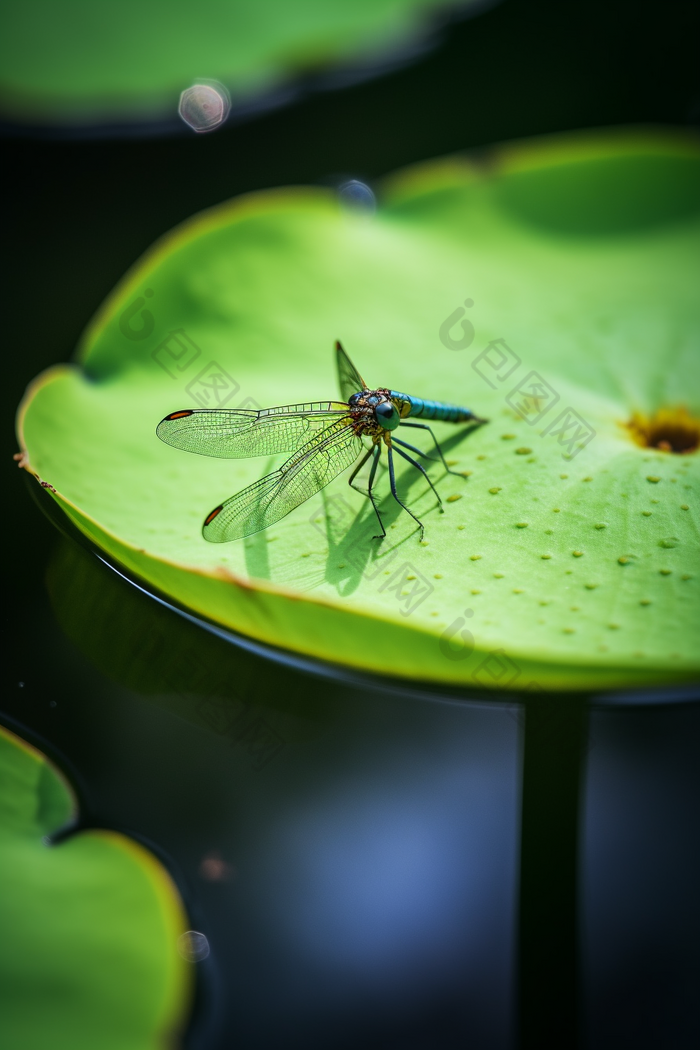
xmin=46 ymin=540 xmax=340 ymax=769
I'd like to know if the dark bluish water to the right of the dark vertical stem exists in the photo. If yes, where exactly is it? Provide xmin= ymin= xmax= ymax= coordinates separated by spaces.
xmin=582 ymin=705 xmax=700 ymax=1050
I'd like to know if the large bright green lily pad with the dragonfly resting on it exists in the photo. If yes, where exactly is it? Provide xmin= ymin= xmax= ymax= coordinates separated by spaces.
xmin=19 ymin=131 xmax=700 ymax=688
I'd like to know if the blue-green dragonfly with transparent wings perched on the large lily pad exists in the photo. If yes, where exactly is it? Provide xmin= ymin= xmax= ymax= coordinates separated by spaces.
xmin=155 ymin=341 xmax=487 ymax=543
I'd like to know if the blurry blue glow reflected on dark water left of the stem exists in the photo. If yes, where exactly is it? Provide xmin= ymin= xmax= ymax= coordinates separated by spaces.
xmin=258 ymin=747 xmax=516 ymax=1000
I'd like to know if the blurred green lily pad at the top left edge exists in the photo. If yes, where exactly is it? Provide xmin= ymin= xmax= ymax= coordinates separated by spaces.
xmin=0 ymin=0 xmax=476 ymax=121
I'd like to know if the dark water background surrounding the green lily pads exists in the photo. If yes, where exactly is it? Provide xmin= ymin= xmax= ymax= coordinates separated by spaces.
xmin=2 ymin=0 xmax=700 ymax=1050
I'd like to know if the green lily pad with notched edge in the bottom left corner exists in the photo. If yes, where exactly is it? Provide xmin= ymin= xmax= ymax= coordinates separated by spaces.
xmin=0 ymin=728 xmax=192 ymax=1050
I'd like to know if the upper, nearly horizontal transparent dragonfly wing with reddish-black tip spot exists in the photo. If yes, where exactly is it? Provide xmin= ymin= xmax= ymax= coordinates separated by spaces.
xmin=155 ymin=401 xmax=347 ymax=459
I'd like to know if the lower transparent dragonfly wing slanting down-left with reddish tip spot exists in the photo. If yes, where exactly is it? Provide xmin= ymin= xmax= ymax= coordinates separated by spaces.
xmin=201 ymin=419 xmax=364 ymax=543
